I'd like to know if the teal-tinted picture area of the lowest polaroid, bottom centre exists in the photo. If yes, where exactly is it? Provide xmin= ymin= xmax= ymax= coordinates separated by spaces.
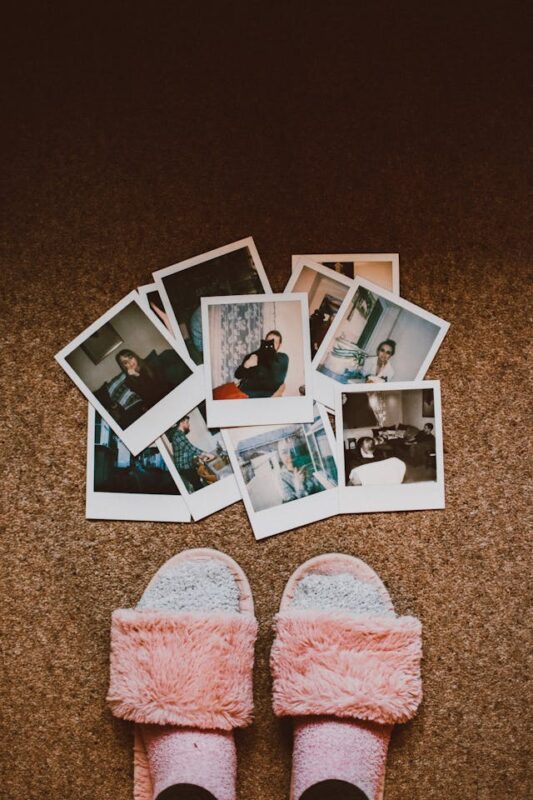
xmin=230 ymin=414 xmax=337 ymax=512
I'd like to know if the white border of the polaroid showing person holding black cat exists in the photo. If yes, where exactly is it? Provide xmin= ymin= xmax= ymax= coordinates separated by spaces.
xmin=202 ymin=292 xmax=313 ymax=428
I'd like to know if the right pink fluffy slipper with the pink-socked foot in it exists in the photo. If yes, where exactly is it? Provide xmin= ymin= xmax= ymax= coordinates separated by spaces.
xmin=271 ymin=553 xmax=422 ymax=800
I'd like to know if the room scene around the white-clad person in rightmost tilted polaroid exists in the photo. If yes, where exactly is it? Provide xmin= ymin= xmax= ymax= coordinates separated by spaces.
xmin=318 ymin=286 xmax=440 ymax=383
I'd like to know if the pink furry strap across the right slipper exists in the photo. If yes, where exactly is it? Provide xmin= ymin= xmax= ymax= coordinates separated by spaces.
xmin=271 ymin=609 xmax=422 ymax=724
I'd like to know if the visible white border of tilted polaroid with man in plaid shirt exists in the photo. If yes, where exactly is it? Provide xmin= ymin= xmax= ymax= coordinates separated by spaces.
xmin=157 ymin=418 xmax=241 ymax=522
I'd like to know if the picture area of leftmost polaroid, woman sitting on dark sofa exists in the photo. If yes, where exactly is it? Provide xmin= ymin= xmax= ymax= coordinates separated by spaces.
xmin=67 ymin=303 xmax=192 ymax=429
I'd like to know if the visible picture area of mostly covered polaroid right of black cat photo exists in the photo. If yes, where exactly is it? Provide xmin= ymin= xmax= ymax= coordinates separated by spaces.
xmin=291 ymin=266 xmax=350 ymax=358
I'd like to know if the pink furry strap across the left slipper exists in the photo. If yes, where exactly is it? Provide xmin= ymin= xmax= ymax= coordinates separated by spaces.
xmin=107 ymin=609 xmax=257 ymax=730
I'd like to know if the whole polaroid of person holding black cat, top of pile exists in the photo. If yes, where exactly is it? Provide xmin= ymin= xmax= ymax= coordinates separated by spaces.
xmin=202 ymin=293 xmax=313 ymax=428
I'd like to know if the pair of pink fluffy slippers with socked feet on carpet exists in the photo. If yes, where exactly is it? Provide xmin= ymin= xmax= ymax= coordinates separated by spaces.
xmin=107 ymin=549 xmax=422 ymax=800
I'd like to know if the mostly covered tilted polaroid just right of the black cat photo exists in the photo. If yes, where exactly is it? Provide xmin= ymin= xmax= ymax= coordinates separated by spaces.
xmin=285 ymin=258 xmax=353 ymax=360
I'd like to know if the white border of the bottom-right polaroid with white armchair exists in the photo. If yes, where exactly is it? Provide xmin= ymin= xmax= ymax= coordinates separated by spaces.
xmin=335 ymin=380 xmax=445 ymax=514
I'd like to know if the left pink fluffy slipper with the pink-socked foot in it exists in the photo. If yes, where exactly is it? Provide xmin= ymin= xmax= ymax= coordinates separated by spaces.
xmin=107 ymin=549 xmax=257 ymax=800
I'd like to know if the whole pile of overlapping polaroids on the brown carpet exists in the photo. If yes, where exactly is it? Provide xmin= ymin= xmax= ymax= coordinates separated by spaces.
xmin=56 ymin=238 xmax=449 ymax=539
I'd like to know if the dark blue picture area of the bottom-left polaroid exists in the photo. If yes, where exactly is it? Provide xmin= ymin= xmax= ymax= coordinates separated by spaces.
xmin=93 ymin=412 xmax=179 ymax=495
